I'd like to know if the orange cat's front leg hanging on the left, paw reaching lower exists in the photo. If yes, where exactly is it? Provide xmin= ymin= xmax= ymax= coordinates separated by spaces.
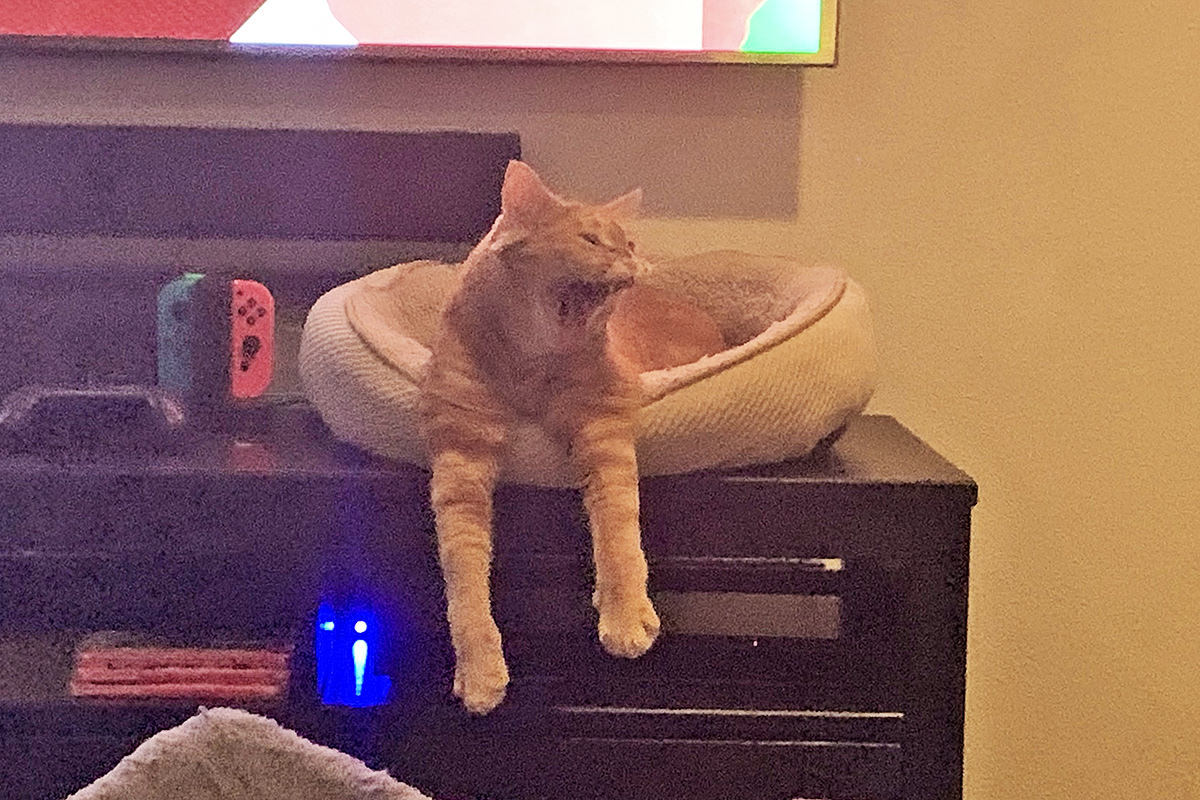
xmin=431 ymin=431 xmax=509 ymax=714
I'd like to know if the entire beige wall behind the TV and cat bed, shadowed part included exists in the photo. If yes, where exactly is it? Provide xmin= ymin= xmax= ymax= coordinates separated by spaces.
xmin=0 ymin=0 xmax=1200 ymax=800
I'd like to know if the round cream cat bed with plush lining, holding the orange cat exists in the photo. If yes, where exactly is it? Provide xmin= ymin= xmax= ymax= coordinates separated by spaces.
xmin=300 ymin=251 xmax=876 ymax=486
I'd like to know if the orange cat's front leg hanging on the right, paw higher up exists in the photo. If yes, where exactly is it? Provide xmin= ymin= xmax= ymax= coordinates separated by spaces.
xmin=571 ymin=417 xmax=659 ymax=658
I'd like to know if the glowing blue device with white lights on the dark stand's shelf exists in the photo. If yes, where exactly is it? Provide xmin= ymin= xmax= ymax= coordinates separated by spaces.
xmin=313 ymin=602 xmax=391 ymax=708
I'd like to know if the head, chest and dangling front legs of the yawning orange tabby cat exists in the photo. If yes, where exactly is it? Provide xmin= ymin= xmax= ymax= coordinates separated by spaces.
xmin=421 ymin=161 xmax=720 ymax=714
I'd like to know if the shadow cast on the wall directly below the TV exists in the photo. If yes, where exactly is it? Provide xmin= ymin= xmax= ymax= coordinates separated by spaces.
xmin=0 ymin=54 xmax=800 ymax=219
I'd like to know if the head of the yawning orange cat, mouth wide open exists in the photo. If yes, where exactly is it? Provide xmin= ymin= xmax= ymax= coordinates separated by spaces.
xmin=491 ymin=161 xmax=646 ymax=330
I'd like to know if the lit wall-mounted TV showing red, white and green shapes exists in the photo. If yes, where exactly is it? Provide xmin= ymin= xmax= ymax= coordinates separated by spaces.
xmin=0 ymin=0 xmax=838 ymax=64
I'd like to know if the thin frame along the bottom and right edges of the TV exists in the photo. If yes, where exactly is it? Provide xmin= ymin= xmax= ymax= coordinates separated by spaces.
xmin=0 ymin=0 xmax=840 ymax=66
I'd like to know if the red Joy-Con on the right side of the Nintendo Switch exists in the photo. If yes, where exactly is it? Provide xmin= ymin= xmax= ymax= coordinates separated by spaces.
xmin=229 ymin=279 xmax=275 ymax=399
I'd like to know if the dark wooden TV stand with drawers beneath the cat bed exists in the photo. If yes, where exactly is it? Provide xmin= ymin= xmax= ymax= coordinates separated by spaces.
xmin=0 ymin=416 xmax=977 ymax=800
